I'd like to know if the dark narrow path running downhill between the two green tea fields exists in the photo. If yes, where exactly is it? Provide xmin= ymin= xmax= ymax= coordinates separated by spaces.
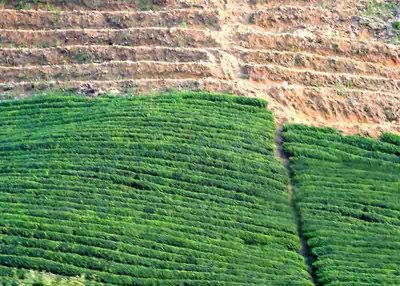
xmin=275 ymin=126 xmax=321 ymax=286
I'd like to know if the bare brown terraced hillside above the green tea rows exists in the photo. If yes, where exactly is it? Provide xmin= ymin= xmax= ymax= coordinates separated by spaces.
xmin=0 ymin=0 xmax=400 ymax=134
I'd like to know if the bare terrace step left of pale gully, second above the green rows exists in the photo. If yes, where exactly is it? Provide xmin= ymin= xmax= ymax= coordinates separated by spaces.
xmin=0 ymin=61 xmax=227 ymax=84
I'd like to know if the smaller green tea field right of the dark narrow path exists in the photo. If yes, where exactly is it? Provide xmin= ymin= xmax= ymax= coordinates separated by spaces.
xmin=284 ymin=125 xmax=400 ymax=286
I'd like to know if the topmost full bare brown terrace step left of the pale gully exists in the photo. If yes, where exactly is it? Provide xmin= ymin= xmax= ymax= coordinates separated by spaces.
xmin=0 ymin=9 xmax=222 ymax=30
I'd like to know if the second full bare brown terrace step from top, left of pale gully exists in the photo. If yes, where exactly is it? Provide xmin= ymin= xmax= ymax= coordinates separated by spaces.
xmin=0 ymin=28 xmax=220 ymax=48
